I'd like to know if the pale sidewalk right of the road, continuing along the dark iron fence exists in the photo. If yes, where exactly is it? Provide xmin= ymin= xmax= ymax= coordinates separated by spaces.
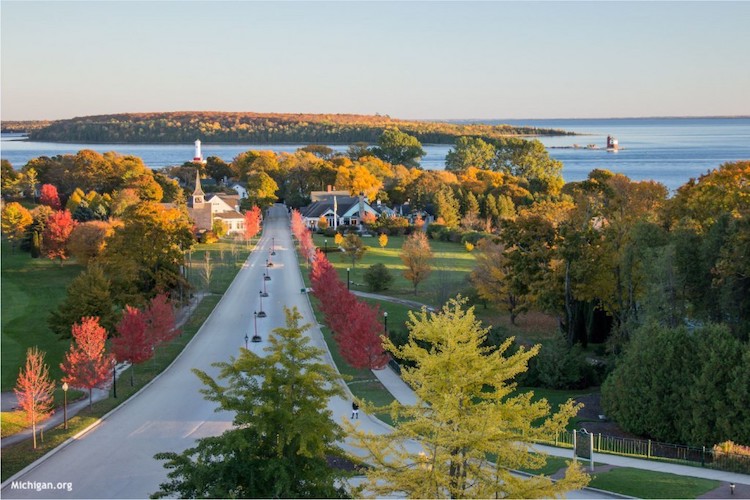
xmin=372 ymin=366 xmax=750 ymax=488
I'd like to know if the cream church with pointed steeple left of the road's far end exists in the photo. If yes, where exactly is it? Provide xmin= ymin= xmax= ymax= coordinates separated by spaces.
xmin=188 ymin=172 xmax=245 ymax=234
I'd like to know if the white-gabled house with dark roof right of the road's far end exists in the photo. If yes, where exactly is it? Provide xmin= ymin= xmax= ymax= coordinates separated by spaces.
xmin=300 ymin=191 xmax=380 ymax=229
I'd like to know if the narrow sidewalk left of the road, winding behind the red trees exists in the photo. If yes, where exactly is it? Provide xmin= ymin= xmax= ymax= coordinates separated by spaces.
xmin=0 ymin=292 xmax=206 ymax=448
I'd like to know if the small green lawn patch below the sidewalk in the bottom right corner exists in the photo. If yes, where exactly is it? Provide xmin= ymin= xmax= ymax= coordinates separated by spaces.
xmin=589 ymin=467 xmax=721 ymax=498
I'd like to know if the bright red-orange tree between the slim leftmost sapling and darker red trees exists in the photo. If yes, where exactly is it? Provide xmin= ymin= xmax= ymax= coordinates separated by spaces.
xmin=60 ymin=316 xmax=114 ymax=409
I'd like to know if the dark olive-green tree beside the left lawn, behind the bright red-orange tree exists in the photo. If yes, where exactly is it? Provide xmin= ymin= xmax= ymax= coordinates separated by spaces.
xmin=47 ymin=262 xmax=116 ymax=339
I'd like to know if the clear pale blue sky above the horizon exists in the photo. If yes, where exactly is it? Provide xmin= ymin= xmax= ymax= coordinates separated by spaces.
xmin=0 ymin=0 xmax=750 ymax=120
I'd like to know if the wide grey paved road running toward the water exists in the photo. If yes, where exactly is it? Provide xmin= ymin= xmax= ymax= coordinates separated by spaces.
xmin=1 ymin=206 xmax=602 ymax=498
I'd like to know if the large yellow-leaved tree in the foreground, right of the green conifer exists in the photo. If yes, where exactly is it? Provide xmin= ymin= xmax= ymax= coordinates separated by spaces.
xmin=345 ymin=298 xmax=588 ymax=498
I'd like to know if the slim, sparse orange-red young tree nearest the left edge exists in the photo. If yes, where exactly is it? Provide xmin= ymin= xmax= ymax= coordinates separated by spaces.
xmin=13 ymin=347 xmax=55 ymax=449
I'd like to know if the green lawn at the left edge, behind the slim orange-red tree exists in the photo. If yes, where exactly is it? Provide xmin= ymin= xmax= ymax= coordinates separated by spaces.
xmin=0 ymin=240 xmax=83 ymax=391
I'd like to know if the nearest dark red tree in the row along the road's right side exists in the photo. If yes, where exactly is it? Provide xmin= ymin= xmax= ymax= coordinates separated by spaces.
xmin=336 ymin=300 xmax=388 ymax=370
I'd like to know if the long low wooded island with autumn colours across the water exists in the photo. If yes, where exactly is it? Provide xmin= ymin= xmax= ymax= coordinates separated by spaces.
xmin=26 ymin=112 xmax=567 ymax=144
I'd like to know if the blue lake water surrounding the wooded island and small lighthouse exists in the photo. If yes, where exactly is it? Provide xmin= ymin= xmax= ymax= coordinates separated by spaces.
xmin=0 ymin=118 xmax=750 ymax=190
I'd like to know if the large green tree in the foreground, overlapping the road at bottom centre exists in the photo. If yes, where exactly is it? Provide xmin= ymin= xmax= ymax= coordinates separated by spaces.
xmin=155 ymin=308 xmax=352 ymax=498
